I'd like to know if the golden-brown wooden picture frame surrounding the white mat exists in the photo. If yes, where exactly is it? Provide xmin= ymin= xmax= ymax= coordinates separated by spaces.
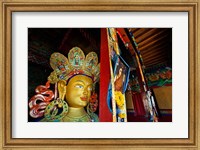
xmin=0 ymin=0 xmax=200 ymax=150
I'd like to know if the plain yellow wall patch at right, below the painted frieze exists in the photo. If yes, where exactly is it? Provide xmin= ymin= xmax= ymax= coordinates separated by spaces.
xmin=153 ymin=86 xmax=172 ymax=109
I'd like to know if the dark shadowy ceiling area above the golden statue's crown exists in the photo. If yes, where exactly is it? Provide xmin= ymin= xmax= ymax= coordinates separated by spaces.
xmin=28 ymin=28 xmax=100 ymax=68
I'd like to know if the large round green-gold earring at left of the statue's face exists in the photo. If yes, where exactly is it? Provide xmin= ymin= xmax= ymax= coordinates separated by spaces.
xmin=44 ymin=98 xmax=68 ymax=122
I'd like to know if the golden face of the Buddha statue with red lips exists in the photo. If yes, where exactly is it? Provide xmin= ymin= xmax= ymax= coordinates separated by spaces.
xmin=66 ymin=75 xmax=93 ymax=108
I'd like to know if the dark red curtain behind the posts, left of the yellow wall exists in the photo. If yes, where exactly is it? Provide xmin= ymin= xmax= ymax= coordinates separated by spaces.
xmin=132 ymin=93 xmax=146 ymax=116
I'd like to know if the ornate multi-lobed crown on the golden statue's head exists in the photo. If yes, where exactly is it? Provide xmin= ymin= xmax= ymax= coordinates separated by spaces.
xmin=48 ymin=47 xmax=100 ymax=84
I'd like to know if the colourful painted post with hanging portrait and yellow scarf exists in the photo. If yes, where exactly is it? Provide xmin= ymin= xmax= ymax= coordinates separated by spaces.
xmin=108 ymin=28 xmax=130 ymax=122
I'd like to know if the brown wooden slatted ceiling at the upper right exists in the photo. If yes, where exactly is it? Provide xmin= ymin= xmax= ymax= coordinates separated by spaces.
xmin=129 ymin=28 xmax=172 ymax=68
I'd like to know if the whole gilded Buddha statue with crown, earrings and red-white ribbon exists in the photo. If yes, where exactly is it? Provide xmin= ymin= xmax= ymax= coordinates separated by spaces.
xmin=29 ymin=47 xmax=100 ymax=122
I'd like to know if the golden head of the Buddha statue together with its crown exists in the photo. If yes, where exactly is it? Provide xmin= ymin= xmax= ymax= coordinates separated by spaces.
xmin=44 ymin=47 xmax=100 ymax=121
